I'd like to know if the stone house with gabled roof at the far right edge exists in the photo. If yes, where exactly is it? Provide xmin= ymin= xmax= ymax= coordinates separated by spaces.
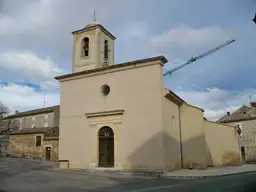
xmin=217 ymin=102 xmax=256 ymax=162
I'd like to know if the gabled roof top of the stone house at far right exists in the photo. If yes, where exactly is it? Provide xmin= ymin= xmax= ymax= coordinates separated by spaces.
xmin=217 ymin=105 xmax=256 ymax=123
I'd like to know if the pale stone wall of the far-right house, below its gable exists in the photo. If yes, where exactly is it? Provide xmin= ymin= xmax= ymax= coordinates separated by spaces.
xmin=229 ymin=120 xmax=256 ymax=161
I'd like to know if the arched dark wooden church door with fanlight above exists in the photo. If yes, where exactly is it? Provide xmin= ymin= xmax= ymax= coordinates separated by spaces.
xmin=99 ymin=126 xmax=114 ymax=167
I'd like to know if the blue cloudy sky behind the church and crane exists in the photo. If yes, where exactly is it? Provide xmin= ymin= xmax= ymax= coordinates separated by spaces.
xmin=0 ymin=0 xmax=256 ymax=120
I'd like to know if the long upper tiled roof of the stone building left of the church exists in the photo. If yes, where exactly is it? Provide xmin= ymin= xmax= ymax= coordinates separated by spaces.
xmin=5 ymin=105 xmax=60 ymax=119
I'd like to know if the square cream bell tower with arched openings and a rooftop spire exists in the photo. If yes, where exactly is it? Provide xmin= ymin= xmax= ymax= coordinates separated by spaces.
xmin=72 ymin=13 xmax=116 ymax=73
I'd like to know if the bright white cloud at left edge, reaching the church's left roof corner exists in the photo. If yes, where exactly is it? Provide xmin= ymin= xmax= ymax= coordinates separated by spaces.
xmin=0 ymin=52 xmax=67 ymax=90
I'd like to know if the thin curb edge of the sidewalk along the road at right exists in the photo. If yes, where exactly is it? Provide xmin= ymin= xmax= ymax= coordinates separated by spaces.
xmin=163 ymin=170 xmax=256 ymax=179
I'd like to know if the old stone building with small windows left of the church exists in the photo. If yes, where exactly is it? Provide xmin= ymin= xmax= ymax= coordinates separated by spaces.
xmin=5 ymin=105 xmax=59 ymax=160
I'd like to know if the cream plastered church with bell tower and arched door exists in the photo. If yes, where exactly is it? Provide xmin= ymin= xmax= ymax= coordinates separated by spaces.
xmin=55 ymin=18 xmax=241 ymax=170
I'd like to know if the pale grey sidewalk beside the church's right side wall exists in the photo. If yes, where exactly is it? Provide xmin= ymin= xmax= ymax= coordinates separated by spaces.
xmin=163 ymin=165 xmax=256 ymax=179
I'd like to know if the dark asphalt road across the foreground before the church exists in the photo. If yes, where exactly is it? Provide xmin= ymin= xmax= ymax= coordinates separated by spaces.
xmin=0 ymin=158 xmax=256 ymax=192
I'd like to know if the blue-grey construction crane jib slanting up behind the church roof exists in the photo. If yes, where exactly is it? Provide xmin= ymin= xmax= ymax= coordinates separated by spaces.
xmin=163 ymin=39 xmax=235 ymax=76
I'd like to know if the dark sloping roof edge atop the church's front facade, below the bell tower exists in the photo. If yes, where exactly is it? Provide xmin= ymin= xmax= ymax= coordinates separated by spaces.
xmin=55 ymin=56 xmax=168 ymax=80
